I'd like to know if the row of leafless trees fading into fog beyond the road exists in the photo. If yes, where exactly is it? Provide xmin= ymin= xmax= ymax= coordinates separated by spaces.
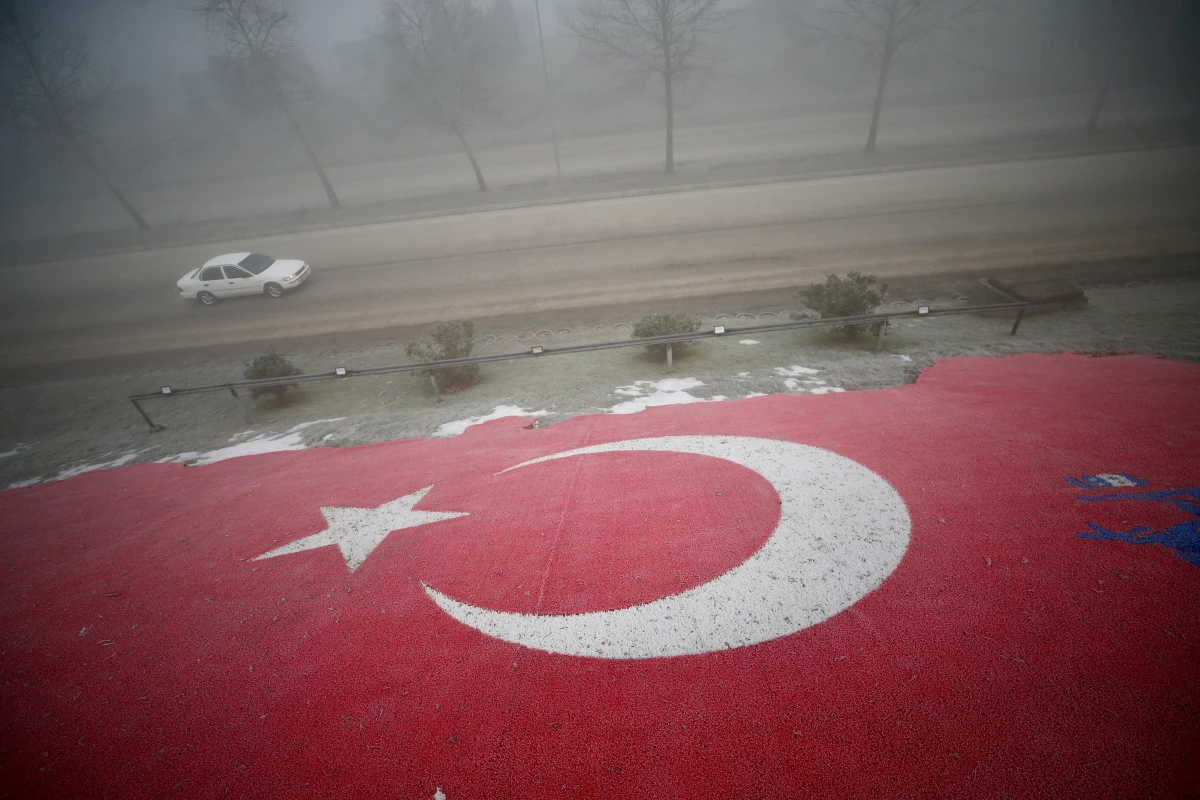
xmin=0 ymin=0 xmax=1200 ymax=228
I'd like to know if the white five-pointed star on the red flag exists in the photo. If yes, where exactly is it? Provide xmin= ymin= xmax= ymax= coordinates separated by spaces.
xmin=254 ymin=486 xmax=467 ymax=572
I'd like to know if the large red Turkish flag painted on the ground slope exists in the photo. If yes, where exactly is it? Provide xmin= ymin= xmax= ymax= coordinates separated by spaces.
xmin=0 ymin=355 xmax=1200 ymax=800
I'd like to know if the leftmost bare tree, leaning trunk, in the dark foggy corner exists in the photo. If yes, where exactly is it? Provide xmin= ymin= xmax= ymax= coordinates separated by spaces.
xmin=0 ymin=0 xmax=150 ymax=230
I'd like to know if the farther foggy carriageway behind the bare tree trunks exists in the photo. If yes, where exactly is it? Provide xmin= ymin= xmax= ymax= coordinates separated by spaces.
xmin=0 ymin=92 xmax=1181 ymax=241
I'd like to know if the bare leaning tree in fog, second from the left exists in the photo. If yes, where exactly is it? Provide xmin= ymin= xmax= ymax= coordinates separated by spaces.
xmin=191 ymin=0 xmax=342 ymax=209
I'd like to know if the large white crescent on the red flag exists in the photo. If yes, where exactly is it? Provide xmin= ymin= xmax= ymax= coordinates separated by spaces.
xmin=421 ymin=435 xmax=910 ymax=658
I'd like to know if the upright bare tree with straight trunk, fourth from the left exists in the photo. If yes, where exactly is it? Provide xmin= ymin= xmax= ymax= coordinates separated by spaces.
xmin=566 ymin=0 xmax=731 ymax=173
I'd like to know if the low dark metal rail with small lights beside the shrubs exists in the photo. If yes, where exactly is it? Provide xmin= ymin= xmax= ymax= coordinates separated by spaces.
xmin=130 ymin=302 xmax=1030 ymax=431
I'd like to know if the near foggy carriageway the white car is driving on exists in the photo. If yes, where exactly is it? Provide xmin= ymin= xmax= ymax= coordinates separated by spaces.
xmin=0 ymin=148 xmax=1200 ymax=366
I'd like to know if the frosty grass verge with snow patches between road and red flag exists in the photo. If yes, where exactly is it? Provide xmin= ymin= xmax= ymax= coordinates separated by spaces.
xmin=0 ymin=281 xmax=1200 ymax=488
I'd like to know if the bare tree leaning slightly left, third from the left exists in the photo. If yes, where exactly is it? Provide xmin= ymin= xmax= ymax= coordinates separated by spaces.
xmin=374 ymin=0 xmax=488 ymax=192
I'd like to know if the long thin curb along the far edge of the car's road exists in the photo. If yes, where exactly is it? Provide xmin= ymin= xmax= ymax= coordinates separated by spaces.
xmin=0 ymin=136 xmax=1200 ymax=263
